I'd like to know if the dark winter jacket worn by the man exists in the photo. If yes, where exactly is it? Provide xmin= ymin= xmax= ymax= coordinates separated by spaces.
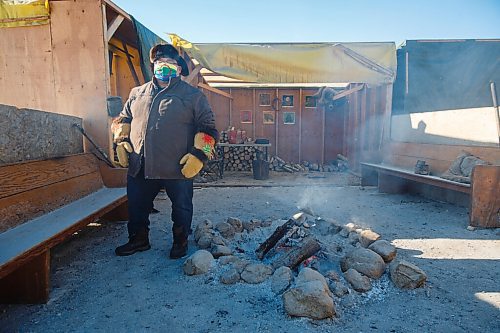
xmin=120 ymin=78 xmax=218 ymax=179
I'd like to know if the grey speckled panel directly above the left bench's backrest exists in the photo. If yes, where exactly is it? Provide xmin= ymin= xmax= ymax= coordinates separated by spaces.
xmin=0 ymin=104 xmax=83 ymax=165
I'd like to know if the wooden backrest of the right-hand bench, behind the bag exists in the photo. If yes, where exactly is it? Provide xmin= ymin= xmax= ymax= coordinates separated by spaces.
xmin=382 ymin=141 xmax=500 ymax=175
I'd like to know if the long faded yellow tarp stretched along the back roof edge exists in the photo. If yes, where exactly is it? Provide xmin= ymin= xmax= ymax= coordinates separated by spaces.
xmin=170 ymin=34 xmax=396 ymax=85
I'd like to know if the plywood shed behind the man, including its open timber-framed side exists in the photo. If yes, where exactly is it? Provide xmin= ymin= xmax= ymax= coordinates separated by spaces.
xmin=0 ymin=0 xmax=201 ymax=156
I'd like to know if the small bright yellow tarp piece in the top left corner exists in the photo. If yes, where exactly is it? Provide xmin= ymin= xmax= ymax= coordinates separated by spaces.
xmin=0 ymin=0 xmax=50 ymax=28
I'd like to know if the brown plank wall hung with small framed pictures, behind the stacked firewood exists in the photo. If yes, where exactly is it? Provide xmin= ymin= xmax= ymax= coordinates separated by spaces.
xmin=206 ymin=85 xmax=392 ymax=165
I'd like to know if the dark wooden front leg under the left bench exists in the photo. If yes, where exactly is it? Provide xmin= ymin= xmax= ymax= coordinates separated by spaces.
xmin=0 ymin=250 xmax=50 ymax=304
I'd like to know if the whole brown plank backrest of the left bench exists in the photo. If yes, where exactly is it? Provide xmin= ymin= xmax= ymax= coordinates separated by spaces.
xmin=0 ymin=154 xmax=104 ymax=232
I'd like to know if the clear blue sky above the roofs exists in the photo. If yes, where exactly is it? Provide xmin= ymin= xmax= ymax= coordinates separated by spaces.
xmin=113 ymin=0 xmax=500 ymax=45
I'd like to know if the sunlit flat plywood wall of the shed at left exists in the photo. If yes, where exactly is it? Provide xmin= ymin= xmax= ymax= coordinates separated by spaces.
xmin=0 ymin=0 xmax=109 ymax=147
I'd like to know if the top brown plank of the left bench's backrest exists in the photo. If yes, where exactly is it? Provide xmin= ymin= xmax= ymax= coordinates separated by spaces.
xmin=0 ymin=154 xmax=97 ymax=199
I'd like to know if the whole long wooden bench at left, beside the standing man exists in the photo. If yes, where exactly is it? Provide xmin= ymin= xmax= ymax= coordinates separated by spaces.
xmin=0 ymin=154 xmax=127 ymax=303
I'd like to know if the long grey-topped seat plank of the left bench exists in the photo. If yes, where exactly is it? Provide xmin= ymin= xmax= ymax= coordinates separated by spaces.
xmin=0 ymin=188 xmax=127 ymax=278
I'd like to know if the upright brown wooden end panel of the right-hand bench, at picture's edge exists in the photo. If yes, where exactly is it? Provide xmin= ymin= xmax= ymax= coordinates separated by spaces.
xmin=470 ymin=165 xmax=500 ymax=228
